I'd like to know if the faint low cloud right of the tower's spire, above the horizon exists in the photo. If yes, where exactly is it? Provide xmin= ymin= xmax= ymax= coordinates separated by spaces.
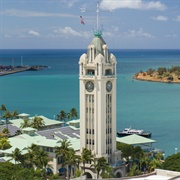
xmin=125 ymin=28 xmax=154 ymax=39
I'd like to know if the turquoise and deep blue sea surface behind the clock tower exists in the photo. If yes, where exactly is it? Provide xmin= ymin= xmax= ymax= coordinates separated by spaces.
xmin=0 ymin=49 xmax=180 ymax=157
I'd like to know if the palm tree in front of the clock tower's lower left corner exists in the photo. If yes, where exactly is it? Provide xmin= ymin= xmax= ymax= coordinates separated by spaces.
xmin=81 ymin=148 xmax=94 ymax=173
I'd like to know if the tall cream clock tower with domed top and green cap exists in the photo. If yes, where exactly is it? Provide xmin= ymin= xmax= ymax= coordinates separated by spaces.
xmin=79 ymin=30 xmax=121 ymax=164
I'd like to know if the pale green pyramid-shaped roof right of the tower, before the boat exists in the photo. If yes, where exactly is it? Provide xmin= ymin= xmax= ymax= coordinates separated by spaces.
xmin=116 ymin=134 xmax=156 ymax=145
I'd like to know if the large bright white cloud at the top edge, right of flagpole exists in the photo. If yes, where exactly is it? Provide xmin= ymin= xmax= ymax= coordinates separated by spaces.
xmin=100 ymin=0 xmax=166 ymax=11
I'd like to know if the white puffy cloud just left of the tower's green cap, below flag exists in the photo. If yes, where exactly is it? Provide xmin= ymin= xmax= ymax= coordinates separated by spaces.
xmin=54 ymin=27 xmax=92 ymax=38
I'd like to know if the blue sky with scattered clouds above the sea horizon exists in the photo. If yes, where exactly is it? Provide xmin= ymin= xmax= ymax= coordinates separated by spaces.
xmin=0 ymin=0 xmax=180 ymax=49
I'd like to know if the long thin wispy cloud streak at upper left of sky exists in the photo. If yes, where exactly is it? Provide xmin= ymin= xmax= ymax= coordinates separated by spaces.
xmin=0 ymin=9 xmax=77 ymax=18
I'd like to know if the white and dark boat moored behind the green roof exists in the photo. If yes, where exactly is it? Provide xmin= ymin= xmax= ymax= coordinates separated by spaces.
xmin=117 ymin=128 xmax=151 ymax=138
